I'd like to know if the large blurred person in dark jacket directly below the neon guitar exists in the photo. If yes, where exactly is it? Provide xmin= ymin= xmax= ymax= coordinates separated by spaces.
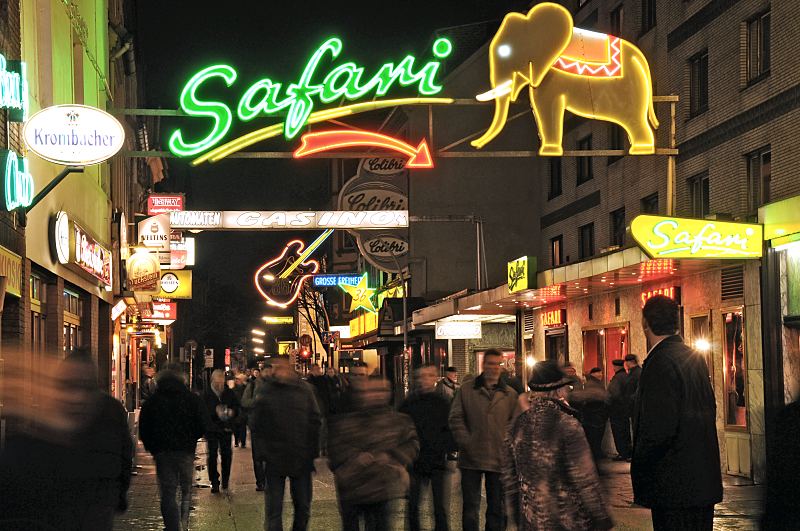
xmin=250 ymin=357 xmax=321 ymax=531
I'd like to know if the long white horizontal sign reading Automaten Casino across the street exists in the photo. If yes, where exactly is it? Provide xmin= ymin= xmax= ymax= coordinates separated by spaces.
xmin=170 ymin=210 xmax=408 ymax=230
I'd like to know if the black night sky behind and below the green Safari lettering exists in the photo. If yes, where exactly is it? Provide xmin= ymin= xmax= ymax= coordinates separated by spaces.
xmin=131 ymin=0 xmax=525 ymax=344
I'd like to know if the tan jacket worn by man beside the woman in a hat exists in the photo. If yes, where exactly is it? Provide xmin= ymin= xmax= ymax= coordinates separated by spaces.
xmin=450 ymin=374 xmax=517 ymax=472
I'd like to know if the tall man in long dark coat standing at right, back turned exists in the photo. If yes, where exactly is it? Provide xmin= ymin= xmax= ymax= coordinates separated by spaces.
xmin=631 ymin=295 xmax=722 ymax=531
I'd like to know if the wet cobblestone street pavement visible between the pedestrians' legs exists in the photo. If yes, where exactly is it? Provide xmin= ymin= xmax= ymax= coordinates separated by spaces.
xmin=115 ymin=443 xmax=762 ymax=531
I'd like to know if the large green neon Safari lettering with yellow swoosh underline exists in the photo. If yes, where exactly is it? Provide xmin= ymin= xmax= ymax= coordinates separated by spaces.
xmin=169 ymin=37 xmax=453 ymax=164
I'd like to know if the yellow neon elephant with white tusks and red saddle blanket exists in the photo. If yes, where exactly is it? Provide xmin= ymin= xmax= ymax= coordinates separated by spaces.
xmin=472 ymin=2 xmax=658 ymax=156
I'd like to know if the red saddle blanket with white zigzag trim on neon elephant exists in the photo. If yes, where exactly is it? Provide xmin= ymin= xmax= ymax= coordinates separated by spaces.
xmin=553 ymin=28 xmax=622 ymax=77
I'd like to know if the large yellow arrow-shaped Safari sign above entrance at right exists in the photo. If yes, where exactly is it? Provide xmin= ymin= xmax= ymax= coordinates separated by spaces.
xmin=631 ymin=216 xmax=763 ymax=259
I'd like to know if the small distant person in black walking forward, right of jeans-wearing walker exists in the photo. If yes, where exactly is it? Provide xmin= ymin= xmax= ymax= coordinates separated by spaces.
xmin=203 ymin=369 xmax=239 ymax=494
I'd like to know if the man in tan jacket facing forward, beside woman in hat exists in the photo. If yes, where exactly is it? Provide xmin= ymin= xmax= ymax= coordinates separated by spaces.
xmin=450 ymin=349 xmax=517 ymax=531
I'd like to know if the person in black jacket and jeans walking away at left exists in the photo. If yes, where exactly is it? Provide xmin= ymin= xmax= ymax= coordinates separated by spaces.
xmin=139 ymin=365 xmax=208 ymax=531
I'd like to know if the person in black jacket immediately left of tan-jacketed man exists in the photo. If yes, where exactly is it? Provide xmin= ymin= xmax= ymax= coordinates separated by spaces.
xmin=400 ymin=365 xmax=456 ymax=531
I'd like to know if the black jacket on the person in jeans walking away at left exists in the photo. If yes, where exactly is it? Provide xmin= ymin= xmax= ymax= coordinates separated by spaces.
xmin=139 ymin=377 xmax=210 ymax=455
